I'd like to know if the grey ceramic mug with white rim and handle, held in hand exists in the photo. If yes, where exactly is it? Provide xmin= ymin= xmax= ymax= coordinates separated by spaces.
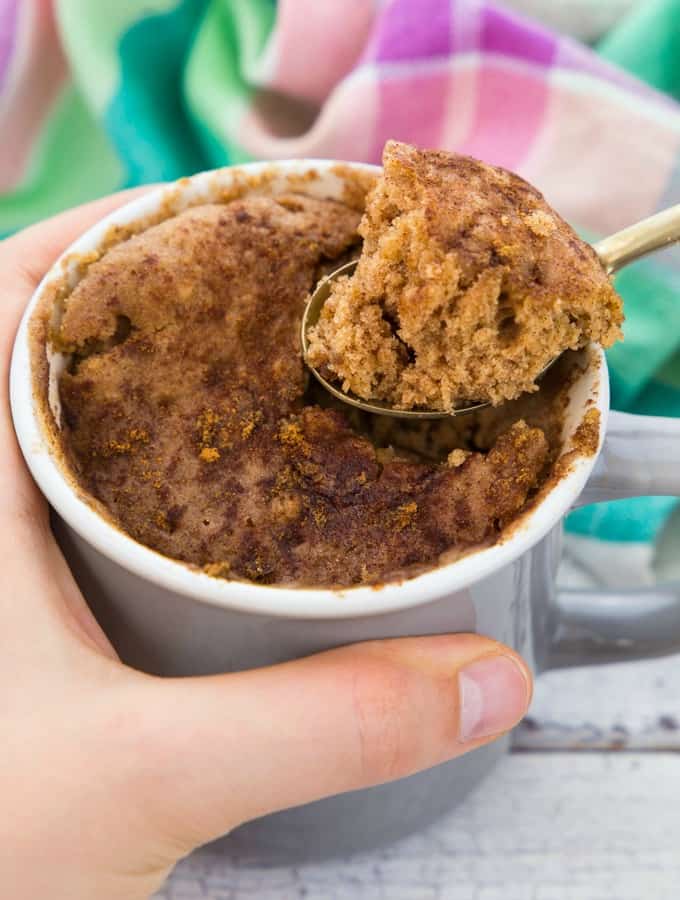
xmin=11 ymin=160 xmax=680 ymax=862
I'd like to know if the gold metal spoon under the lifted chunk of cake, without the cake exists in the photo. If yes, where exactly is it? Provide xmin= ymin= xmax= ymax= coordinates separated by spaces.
xmin=300 ymin=203 xmax=680 ymax=419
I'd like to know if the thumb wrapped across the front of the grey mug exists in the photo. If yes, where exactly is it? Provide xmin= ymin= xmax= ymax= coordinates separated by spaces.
xmin=139 ymin=635 xmax=531 ymax=850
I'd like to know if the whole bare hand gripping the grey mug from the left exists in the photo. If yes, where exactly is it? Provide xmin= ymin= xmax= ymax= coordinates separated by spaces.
xmin=0 ymin=194 xmax=531 ymax=900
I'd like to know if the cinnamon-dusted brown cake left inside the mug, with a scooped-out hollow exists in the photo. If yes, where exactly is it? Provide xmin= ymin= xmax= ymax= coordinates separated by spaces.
xmin=56 ymin=195 xmax=548 ymax=585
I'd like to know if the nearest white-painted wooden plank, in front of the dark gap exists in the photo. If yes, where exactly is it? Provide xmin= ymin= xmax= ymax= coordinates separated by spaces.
xmin=157 ymin=753 xmax=680 ymax=900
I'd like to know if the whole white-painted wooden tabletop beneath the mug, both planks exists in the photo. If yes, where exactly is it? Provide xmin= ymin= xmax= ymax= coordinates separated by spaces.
xmin=157 ymin=657 xmax=680 ymax=900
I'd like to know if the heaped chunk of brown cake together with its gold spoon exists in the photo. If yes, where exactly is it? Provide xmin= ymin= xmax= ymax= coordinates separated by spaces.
xmin=302 ymin=141 xmax=680 ymax=418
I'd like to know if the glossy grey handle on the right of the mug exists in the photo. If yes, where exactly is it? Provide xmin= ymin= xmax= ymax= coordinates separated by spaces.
xmin=545 ymin=412 xmax=680 ymax=669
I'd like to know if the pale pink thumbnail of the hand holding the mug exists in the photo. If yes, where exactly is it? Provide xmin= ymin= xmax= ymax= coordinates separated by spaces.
xmin=458 ymin=655 xmax=530 ymax=742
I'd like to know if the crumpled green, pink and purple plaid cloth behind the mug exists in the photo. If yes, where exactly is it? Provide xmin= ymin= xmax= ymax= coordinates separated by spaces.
xmin=0 ymin=0 xmax=680 ymax=581
